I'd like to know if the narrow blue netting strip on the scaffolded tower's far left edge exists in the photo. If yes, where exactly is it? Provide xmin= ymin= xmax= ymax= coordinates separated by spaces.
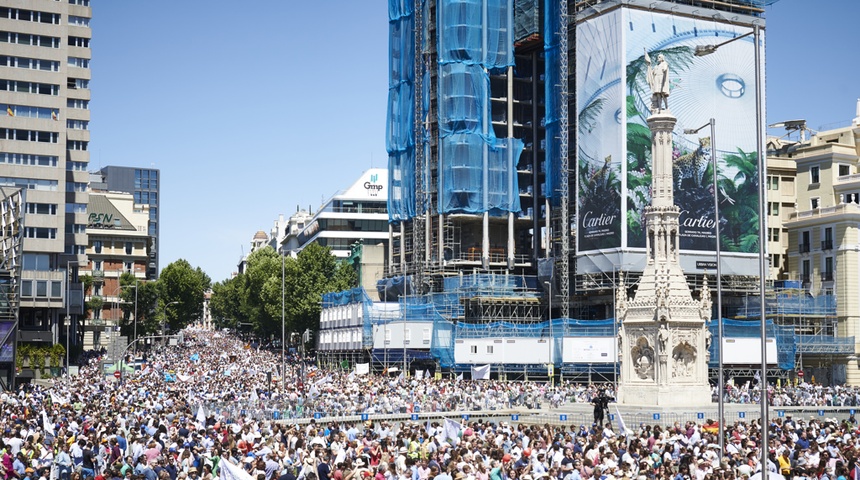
xmin=385 ymin=0 xmax=415 ymax=223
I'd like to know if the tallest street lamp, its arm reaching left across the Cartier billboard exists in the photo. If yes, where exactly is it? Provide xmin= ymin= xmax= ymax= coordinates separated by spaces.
xmin=696 ymin=23 xmax=769 ymax=472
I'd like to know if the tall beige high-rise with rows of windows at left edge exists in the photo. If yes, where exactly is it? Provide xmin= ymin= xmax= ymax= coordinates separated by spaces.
xmin=0 ymin=0 xmax=92 ymax=362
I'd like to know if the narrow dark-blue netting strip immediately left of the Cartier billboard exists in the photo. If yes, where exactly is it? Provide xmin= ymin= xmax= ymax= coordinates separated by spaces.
xmin=543 ymin=1 xmax=567 ymax=205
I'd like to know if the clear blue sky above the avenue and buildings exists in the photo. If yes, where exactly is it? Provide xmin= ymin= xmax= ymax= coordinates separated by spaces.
xmin=90 ymin=0 xmax=860 ymax=281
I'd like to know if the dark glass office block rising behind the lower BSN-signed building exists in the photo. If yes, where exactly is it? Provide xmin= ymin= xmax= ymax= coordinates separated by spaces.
xmin=92 ymin=166 xmax=161 ymax=279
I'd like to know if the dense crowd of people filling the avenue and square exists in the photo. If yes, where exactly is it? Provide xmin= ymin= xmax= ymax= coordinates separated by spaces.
xmin=5 ymin=331 xmax=860 ymax=480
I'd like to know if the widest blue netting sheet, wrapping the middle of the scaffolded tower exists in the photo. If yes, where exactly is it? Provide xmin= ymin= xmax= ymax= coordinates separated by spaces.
xmin=437 ymin=0 xmax=523 ymax=215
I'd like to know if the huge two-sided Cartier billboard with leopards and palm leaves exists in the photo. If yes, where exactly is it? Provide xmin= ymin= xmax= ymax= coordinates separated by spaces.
xmin=576 ymin=7 xmax=763 ymax=274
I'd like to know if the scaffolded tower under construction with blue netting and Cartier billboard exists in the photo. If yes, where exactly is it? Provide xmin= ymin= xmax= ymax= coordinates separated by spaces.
xmin=310 ymin=0 xmax=852 ymax=382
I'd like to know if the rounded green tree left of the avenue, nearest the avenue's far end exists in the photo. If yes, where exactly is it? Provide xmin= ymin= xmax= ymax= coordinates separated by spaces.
xmin=156 ymin=259 xmax=211 ymax=332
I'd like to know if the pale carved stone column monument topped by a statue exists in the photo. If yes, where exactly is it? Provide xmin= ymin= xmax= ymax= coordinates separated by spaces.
xmin=615 ymin=52 xmax=711 ymax=406
